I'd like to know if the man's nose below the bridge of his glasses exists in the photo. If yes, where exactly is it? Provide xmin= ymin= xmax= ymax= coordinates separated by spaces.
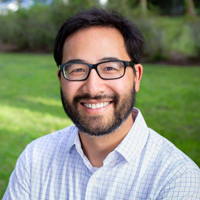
xmin=82 ymin=69 xmax=106 ymax=96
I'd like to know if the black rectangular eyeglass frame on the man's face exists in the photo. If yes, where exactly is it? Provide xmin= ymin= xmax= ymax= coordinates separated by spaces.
xmin=58 ymin=60 xmax=136 ymax=81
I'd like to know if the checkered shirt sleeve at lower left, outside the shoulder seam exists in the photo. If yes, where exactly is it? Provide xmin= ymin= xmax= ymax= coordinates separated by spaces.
xmin=2 ymin=150 xmax=30 ymax=200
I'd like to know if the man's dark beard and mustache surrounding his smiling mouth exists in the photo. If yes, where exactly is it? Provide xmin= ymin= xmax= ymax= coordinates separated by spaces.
xmin=60 ymin=85 xmax=136 ymax=136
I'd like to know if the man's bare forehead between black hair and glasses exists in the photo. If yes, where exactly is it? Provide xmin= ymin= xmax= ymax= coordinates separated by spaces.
xmin=63 ymin=27 xmax=129 ymax=62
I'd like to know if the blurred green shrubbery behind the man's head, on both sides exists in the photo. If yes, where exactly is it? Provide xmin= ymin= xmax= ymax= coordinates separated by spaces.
xmin=0 ymin=0 xmax=200 ymax=61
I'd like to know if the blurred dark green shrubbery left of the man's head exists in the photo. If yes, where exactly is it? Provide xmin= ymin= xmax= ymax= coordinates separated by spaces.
xmin=0 ymin=0 xmax=98 ymax=51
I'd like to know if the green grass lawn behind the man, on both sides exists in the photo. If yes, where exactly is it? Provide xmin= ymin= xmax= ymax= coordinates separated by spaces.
xmin=0 ymin=53 xmax=200 ymax=198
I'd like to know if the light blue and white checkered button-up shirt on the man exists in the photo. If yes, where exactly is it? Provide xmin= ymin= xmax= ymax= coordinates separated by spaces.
xmin=3 ymin=108 xmax=200 ymax=200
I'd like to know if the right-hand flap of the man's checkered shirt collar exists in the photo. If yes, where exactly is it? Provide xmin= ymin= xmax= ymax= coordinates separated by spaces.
xmin=115 ymin=108 xmax=149 ymax=162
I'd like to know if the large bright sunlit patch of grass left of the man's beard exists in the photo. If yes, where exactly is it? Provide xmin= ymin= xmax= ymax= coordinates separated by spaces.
xmin=0 ymin=104 xmax=71 ymax=137
